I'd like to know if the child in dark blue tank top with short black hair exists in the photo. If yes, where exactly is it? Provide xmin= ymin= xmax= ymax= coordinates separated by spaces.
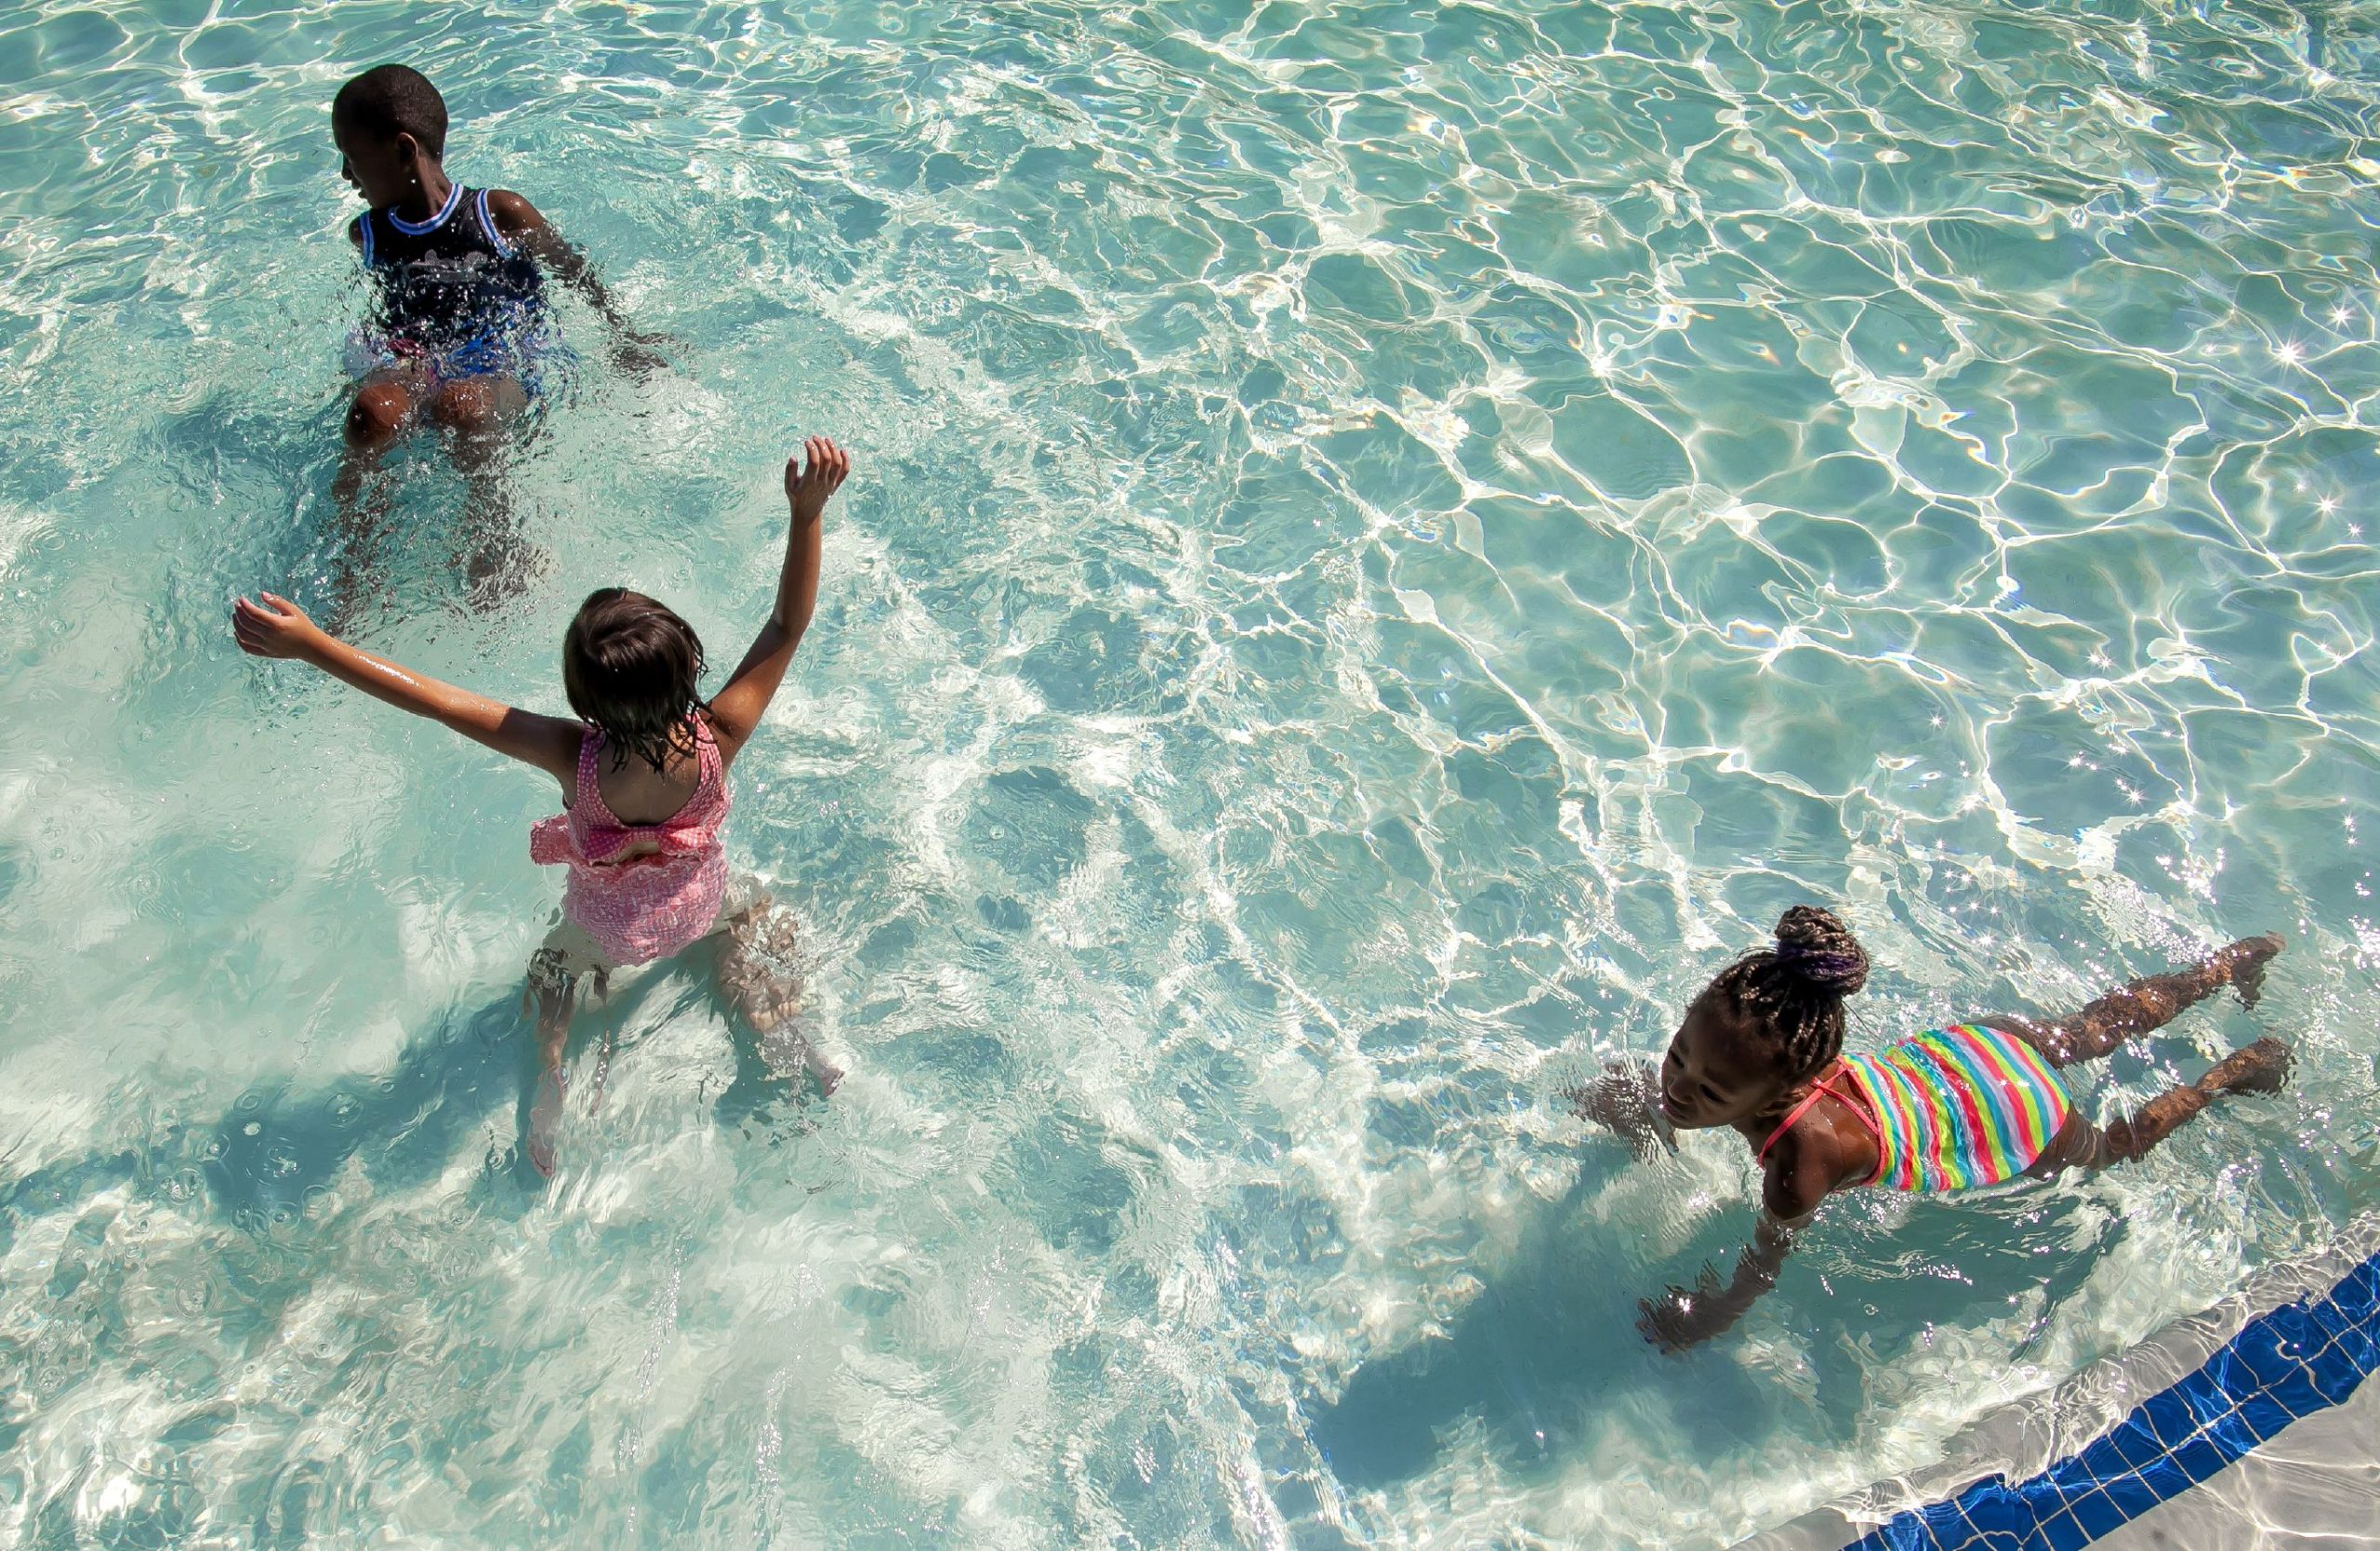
xmin=331 ymin=64 xmax=657 ymax=608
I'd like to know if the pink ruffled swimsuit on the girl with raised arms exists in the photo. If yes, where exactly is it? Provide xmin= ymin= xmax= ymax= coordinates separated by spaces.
xmin=528 ymin=716 xmax=728 ymax=966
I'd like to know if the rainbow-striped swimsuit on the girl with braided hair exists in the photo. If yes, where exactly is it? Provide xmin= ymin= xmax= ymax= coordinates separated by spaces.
xmin=1842 ymin=1023 xmax=2073 ymax=1189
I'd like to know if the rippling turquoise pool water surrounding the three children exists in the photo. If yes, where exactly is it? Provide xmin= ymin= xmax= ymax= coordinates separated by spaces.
xmin=0 ymin=0 xmax=2380 ymax=1548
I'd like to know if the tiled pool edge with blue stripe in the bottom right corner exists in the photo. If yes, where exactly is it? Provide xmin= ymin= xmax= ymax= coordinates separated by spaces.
xmin=1739 ymin=1215 xmax=2380 ymax=1551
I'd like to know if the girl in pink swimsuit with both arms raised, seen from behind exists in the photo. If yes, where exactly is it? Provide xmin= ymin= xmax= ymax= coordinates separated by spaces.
xmin=231 ymin=435 xmax=852 ymax=1173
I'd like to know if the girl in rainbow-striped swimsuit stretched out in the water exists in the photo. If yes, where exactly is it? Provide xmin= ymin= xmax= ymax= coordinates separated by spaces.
xmin=1571 ymin=904 xmax=2290 ymax=1351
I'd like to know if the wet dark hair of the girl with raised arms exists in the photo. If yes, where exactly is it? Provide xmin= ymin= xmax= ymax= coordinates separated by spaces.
xmin=562 ymin=588 xmax=709 ymax=773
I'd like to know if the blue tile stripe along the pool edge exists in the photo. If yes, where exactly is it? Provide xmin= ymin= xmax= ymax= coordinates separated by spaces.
xmin=1844 ymin=1253 xmax=2380 ymax=1551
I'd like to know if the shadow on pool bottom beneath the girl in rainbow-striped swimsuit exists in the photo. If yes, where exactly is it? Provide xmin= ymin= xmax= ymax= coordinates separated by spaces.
xmin=1306 ymin=1170 xmax=2125 ymax=1491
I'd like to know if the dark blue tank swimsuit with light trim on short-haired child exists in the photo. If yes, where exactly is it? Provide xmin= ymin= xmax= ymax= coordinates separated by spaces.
xmin=362 ymin=183 xmax=549 ymax=392
